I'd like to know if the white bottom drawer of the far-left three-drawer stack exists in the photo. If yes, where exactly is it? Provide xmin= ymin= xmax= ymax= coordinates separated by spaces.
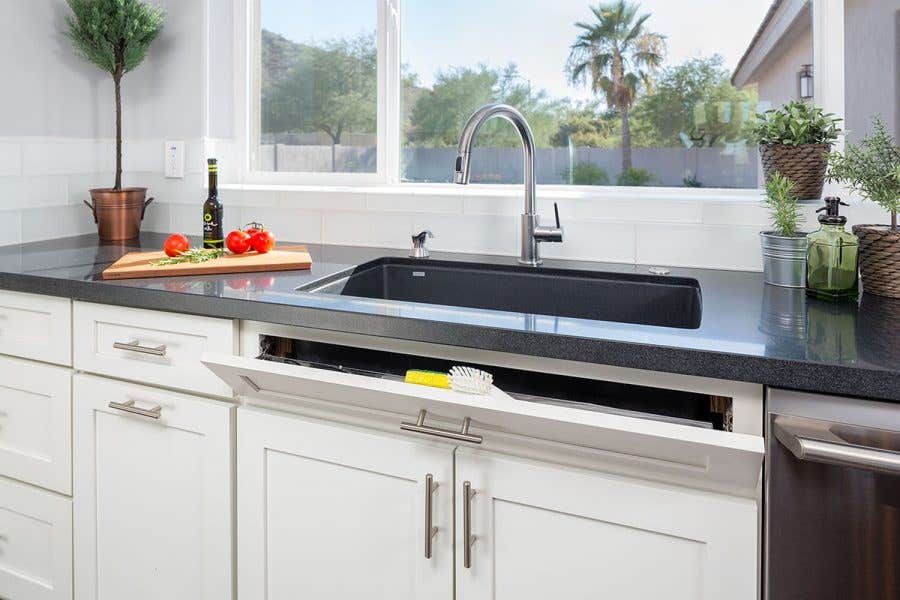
xmin=0 ymin=478 xmax=72 ymax=600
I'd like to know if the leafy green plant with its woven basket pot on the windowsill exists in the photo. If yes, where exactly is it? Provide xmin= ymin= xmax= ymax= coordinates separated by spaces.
xmin=750 ymin=100 xmax=841 ymax=200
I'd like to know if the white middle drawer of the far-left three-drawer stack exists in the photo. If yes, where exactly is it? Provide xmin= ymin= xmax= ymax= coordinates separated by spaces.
xmin=0 ymin=356 xmax=72 ymax=492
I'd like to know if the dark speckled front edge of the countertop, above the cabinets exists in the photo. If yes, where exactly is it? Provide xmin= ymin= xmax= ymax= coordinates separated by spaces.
xmin=0 ymin=273 xmax=900 ymax=401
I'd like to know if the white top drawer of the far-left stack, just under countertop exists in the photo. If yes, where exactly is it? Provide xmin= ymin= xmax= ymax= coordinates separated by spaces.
xmin=0 ymin=291 xmax=72 ymax=365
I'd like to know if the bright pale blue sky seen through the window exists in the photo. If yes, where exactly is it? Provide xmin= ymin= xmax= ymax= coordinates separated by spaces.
xmin=261 ymin=0 xmax=771 ymax=99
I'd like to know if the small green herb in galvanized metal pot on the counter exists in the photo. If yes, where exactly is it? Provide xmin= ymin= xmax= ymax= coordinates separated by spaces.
xmin=759 ymin=171 xmax=806 ymax=288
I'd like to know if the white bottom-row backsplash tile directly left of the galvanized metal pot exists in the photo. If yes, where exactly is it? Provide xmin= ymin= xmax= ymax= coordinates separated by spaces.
xmin=636 ymin=224 xmax=762 ymax=271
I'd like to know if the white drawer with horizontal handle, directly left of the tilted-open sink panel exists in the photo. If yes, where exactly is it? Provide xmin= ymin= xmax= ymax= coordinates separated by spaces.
xmin=74 ymin=302 xmax=237 ymax=398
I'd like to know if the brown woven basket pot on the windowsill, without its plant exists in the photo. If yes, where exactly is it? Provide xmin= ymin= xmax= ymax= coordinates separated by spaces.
xmin=759 ymin=144 xmax=831 ymax=200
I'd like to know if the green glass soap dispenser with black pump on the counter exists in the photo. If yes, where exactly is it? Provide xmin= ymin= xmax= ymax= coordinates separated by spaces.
xmin=806 ymin=196 xmax=859 ymax=302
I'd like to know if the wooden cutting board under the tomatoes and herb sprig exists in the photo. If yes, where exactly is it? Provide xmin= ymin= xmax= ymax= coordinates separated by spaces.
xmin=103 ymin=246 xmax=312 ymax=279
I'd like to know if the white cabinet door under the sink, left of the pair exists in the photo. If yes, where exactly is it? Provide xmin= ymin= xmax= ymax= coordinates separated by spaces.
xmin=237 ymin=408 xmax=453 ymax=600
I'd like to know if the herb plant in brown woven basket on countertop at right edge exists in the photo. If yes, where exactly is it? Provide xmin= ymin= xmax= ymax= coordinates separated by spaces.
xmin=828 ymin=117 xmax=900 ymax=298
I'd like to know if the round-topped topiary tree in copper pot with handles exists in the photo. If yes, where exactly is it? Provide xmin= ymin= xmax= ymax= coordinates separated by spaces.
xmin=66 ymin=0 xmax=165 ymax=240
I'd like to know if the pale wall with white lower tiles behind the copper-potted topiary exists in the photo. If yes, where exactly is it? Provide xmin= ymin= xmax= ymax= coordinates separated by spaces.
xmin=0 ymin=0 xmax=203 ymax=241
